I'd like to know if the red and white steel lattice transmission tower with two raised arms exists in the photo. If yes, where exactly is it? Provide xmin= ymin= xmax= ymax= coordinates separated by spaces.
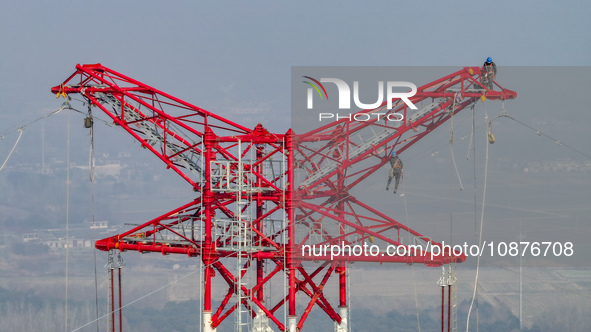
xmin=52 ymin=64 xmax=516 ymax=332
